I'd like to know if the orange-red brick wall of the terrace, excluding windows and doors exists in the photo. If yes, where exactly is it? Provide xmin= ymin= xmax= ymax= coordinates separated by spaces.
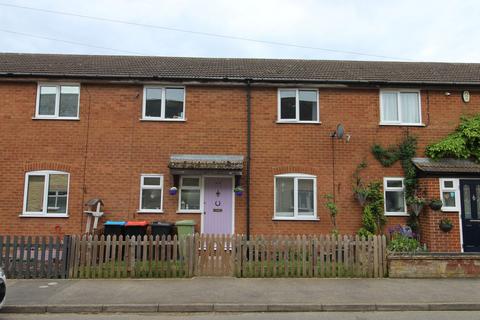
xmin=0 ymin=82 xmax=480 ymax=250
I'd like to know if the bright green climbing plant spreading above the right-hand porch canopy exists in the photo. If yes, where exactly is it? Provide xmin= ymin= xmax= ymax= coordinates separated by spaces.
xmin=425 ymin=114 xmax=480 ymax=162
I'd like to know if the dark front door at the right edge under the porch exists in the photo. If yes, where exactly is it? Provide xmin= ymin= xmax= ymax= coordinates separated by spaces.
xmin=460 ymin=180 xmax=480 ymax=252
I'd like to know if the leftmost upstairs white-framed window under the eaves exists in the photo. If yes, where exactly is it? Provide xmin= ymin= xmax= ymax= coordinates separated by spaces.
xmin=35 ymin=83 xmax=80 ymax=120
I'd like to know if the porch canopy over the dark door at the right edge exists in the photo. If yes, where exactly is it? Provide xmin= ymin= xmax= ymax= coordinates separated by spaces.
xmin=412 ymin=158 xmax=480 ymax=177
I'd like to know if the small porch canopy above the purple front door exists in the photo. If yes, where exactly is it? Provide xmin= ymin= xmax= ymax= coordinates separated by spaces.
xmin=168 ymin=154 xmax=243 ymax=176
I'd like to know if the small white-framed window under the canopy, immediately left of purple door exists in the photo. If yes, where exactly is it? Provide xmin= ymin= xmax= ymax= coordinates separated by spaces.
xmin=178 ymin=176 xmax=202 ymax=212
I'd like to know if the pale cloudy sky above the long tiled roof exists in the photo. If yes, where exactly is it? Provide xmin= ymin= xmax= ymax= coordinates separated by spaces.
xmin=0 ymin=0 xmax=480 ymax=62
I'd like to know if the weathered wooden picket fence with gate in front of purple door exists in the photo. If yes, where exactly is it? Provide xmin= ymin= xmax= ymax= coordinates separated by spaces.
xmin=67 ymin=234 xmax=387 ymax=278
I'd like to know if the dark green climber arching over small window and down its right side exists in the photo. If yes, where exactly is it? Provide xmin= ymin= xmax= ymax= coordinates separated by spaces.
xmin=372 ymin=134 xmax=418 ymax=231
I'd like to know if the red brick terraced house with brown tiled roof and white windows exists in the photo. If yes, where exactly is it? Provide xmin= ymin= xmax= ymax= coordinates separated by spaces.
xmin=0 ymin=53 xmax=480 ymax=251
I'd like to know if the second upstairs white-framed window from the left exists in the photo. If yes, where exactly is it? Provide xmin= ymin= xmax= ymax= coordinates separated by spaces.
xmin=142 ymin=86 xmax=185 ymax=121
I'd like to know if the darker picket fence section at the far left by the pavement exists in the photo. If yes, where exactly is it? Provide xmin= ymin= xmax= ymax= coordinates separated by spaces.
xmin=0 ymin=236 xmax=70 ymax=279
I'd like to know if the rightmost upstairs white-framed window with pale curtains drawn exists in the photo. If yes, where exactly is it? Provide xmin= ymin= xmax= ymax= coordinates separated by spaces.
xmin=380 ymin=89 xmax=422 ymax=126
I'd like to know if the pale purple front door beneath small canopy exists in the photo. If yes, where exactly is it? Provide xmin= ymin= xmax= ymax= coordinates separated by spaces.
xmin=202 ymin=177 xmax=233 ymax=234
